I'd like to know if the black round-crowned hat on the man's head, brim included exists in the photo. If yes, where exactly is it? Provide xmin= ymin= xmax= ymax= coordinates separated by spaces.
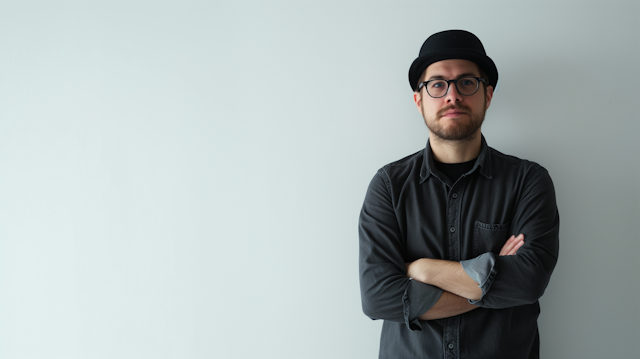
xmin=409 ymin=30 xmax=498 ymax=91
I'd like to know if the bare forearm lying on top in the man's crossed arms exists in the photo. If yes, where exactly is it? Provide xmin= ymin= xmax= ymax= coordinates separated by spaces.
xmin=407 ymin=258 xmax=482 ymax=300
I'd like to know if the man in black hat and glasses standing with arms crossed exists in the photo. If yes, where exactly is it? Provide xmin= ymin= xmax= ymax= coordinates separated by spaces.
xmin=359 ymin=30 xmax=559 ymax=359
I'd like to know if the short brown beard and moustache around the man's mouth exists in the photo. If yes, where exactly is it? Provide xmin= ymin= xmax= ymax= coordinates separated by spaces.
xmin=423 ymin=102 xmax=487 ymax=141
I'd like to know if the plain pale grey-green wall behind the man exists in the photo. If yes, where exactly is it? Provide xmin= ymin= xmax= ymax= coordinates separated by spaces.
xmin=0 ymin=0 xmax=640 ymax=359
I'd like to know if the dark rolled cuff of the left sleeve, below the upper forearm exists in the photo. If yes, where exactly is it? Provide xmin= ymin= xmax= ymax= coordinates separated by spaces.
xmin=402 ymin=279 xmax=443 ymax=330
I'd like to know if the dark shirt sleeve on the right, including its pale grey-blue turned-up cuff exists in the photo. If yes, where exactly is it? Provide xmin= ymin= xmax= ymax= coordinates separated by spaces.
xmin=463 ymin=166 xmax=560 ymax=309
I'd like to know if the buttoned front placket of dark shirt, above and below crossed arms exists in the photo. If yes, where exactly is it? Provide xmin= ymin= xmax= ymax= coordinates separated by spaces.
xmin=442 ymin=177 xmax=466 ymax=359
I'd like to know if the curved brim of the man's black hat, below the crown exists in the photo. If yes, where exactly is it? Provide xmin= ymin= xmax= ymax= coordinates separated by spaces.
xmin=409 ymin=49 xmax=498 ymax=91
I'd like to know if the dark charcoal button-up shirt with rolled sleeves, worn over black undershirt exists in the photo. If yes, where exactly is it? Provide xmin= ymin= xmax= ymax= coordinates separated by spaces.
xmin=359 ymin=137 xmax=559 ymax=358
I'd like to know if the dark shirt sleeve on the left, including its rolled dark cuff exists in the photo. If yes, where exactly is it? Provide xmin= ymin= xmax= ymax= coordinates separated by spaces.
xmin=359 ymin=170 xmax=442 ymax=330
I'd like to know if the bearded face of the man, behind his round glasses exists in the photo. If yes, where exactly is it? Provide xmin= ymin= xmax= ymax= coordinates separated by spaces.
xmin=413 ymin=59 xmax=493 ymax=141
